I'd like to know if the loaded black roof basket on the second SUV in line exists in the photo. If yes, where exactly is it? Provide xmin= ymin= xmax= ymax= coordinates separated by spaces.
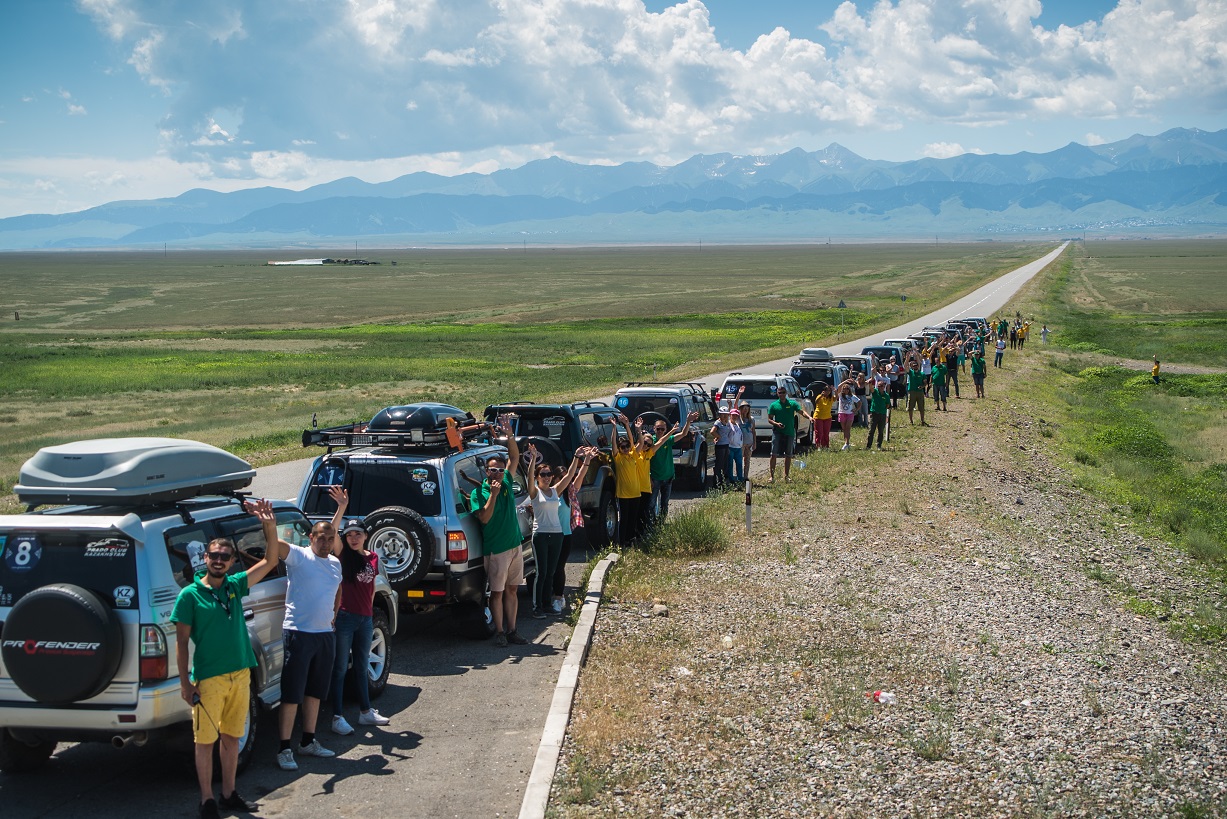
xmin=303 ymin=402 xmax=491 ymax=451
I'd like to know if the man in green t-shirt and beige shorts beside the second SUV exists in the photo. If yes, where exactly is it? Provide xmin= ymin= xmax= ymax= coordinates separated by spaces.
xmin=470 ymin=419 xmax=528 ymax=647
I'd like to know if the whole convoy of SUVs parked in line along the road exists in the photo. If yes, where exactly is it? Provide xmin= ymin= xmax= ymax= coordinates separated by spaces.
xmin=0 ymin=310 xmax=987 ymax=772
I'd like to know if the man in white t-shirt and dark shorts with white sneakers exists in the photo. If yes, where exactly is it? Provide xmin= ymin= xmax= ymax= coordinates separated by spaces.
xmin=277 ymin=521 xmax=341 ymax=771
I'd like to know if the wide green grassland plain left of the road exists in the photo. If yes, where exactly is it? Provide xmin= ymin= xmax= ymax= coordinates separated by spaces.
xmin=0 ymin=243 xmax=1050 ymax=505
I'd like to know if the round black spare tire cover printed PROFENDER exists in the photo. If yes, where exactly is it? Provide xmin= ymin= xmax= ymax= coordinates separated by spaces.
xmin=0 ymin=583 xmax=124 ymax=705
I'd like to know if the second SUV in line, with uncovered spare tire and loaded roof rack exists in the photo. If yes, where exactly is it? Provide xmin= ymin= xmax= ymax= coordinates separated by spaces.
xmin=298 ymin=403 xmax=536 ymax=637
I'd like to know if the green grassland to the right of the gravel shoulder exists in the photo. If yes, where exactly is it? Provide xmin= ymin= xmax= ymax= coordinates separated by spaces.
xmin=1016 ymin=242 xmax=1227 ymax=642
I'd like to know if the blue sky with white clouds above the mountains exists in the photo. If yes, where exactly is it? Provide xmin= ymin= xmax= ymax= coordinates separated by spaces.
xmin=0 ymin=0 xmax=1227 ymax=217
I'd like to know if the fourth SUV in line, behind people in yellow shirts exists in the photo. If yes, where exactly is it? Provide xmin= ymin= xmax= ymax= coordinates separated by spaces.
xmin=614 ymin=381 xmax=717 ymax=491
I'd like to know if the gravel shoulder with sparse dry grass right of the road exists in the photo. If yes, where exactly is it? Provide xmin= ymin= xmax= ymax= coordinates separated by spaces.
xmin=551 ymin=351 xmax=1227 ymax=817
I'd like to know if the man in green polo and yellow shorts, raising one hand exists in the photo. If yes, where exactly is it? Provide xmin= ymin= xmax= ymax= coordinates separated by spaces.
xmin=171 ymin=500 xmax=281 ymax=819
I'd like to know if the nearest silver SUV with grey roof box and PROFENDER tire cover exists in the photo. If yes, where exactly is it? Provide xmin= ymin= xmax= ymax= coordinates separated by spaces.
xmin=0 ymin=438 xmax=398 ymax=772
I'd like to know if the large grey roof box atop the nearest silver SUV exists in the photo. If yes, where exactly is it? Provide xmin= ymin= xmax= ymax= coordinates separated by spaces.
xmin=13 ymin=438 xmax=255 ymax=505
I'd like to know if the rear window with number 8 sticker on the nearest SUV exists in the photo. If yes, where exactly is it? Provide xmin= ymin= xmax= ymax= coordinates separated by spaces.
xmin=0 ymin=530 xmax=140 ymax=609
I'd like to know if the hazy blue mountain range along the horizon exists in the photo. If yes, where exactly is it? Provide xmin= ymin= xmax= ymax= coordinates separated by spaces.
xmin=0 ymin=129 xmax=1227 ymax=250
